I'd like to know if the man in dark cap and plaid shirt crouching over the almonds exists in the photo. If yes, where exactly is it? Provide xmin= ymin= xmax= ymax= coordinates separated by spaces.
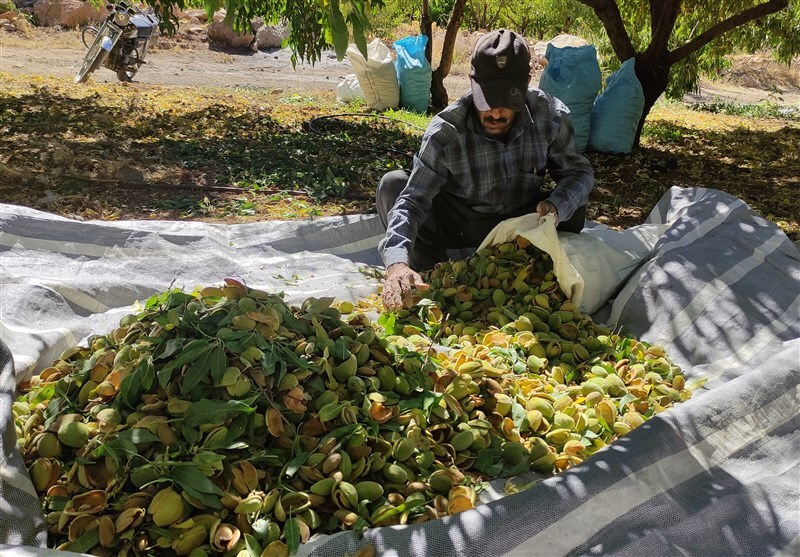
xmin=376 ymin=29 xmax=594 ymax=310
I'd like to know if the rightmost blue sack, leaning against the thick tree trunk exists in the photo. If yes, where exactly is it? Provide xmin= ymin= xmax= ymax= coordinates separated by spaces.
xmin=589 ymin=58 xmax=644 ymax=153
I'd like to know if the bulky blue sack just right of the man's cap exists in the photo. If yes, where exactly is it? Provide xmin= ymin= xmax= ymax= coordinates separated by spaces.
xmin=539 ymin=43 xmax=603 ymax=153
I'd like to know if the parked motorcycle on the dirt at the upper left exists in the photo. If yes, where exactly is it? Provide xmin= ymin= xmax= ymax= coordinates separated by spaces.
xmin=75 ymin=1 xmax=159 ymax=83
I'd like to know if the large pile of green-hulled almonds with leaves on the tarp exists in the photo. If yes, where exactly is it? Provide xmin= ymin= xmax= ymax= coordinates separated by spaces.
xmin=13 ymin=238 xmax=691 ymax=557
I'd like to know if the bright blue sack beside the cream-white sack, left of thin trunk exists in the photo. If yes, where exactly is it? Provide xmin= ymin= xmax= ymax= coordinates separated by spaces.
xmin=394 ymin=35 xmax=432 ymax=112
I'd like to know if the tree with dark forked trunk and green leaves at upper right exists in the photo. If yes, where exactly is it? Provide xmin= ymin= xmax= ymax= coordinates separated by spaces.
xmin=578 ymin=0 xmax=800 ymax=139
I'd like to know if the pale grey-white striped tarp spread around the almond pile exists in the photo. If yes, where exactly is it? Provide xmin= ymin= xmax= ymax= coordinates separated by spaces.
xmin=0 ymin=188 xmax=800 ymax=557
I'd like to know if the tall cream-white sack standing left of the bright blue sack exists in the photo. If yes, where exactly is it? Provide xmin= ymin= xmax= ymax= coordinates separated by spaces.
xmin=347 ymin=39 xmax=400 ymax=110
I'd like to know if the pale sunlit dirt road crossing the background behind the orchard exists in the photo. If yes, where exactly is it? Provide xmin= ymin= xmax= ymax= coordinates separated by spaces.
xmin=0 ymin=26 xmax=800 ymax=107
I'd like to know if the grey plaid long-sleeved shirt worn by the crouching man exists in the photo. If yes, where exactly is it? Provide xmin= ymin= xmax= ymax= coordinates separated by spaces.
xmin=378 ymin=88 xmax=594 ymax=267
